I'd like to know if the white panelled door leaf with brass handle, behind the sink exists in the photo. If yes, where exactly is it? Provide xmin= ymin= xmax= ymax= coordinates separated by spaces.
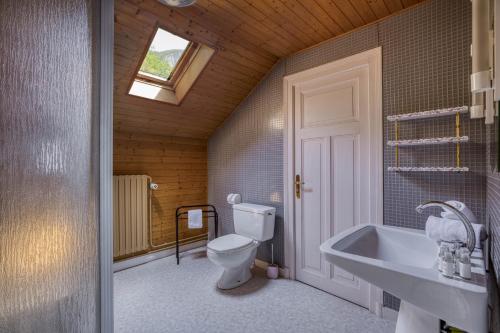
xmin=292 ymin=48 xmax=382 ymax=308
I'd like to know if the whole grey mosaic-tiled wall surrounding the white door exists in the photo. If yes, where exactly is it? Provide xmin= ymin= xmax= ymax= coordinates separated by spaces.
xmin=208 ymin=0 xmax=486 ymax=308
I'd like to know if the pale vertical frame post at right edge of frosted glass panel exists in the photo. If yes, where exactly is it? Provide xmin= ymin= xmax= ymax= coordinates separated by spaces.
xmin=98 ymin=0 xmax=114 ymax=333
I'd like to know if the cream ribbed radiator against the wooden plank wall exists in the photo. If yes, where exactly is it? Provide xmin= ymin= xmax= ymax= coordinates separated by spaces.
xmin=113 ymin=175 xmax=151 ymax=258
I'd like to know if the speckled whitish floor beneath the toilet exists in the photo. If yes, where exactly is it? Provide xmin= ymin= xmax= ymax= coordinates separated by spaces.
xmin=114 ymin=249 xmax=395 ymax=333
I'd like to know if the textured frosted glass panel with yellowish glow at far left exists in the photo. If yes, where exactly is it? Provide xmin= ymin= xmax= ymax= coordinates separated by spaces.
xmin=0 ymin=0 xmax=98 ymax=333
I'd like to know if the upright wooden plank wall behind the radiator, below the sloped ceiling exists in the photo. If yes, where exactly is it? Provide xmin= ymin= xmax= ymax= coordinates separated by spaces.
xmin=113 ymin=131 xmax=208 ymax=247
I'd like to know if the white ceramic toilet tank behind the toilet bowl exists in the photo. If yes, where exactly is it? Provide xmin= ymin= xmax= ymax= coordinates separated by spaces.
xmin=233 ymin=203 xmax=276 ymax=242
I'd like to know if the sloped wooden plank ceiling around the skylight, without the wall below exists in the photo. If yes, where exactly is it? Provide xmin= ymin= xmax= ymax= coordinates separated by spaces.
xmin=114 ymin=0 xmax=423 ymax=139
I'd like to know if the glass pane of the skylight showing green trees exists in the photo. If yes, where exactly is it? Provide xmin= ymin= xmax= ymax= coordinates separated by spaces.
xmin=139 ymin=28 xmax=190 ymax=81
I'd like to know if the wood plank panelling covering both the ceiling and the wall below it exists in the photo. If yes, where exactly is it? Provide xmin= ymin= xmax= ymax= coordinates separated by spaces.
xmin=114 ymin=0 xmax=421 ymax=252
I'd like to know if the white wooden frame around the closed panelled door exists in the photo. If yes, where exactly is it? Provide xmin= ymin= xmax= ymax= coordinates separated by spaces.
xmin=283 ymin=47 xmax=383 ymax=316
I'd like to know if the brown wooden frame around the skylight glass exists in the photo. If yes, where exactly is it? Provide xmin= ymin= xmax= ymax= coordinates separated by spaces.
xmin=132 ymin=25 xmax=199 ymax=89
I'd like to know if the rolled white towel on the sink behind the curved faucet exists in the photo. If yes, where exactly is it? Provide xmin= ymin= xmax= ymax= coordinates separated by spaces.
xmin=425 ymin=215 xmax=486 ymax=248
